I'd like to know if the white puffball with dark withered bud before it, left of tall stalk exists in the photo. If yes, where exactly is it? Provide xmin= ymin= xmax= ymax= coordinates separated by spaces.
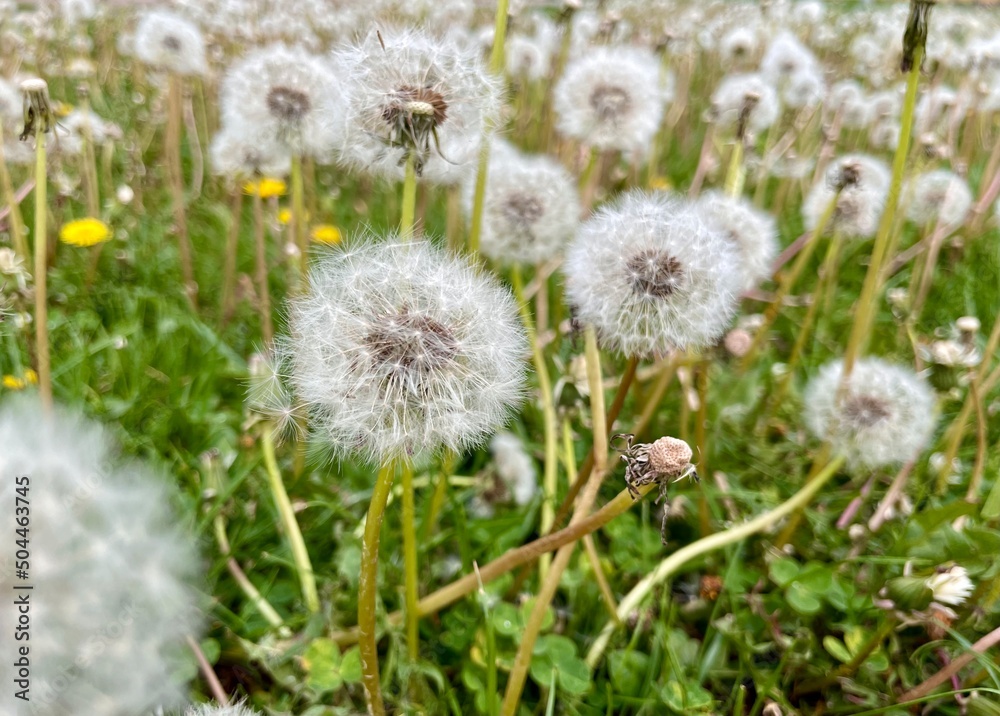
xmin=802 ymin=154 xmax=890 ymax=239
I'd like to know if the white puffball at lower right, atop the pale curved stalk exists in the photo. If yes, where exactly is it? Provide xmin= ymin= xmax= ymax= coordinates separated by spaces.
xmin=805 ymin=358 xmax=936 ymax=468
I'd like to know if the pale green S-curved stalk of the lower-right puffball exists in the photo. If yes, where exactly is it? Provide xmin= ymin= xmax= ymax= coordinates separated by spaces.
xmin=587 ymin=456 xmax=844 ymax=669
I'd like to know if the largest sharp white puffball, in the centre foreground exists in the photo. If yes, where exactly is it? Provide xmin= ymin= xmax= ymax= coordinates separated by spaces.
xmin=289 ymin=236 xmax=527 ymax=462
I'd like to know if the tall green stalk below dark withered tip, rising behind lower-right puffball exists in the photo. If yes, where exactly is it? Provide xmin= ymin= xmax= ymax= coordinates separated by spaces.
xmin=843 ymin=44 xmax=924 ymax=381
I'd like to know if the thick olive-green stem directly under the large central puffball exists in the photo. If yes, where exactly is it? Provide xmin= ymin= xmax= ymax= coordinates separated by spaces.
xmin=358 ymin=463 xmax=395 ymax=716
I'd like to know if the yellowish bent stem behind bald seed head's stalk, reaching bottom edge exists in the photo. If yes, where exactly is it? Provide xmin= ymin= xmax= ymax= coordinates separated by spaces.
xmin=500 ymin=327 xmax=608 ymax=716
